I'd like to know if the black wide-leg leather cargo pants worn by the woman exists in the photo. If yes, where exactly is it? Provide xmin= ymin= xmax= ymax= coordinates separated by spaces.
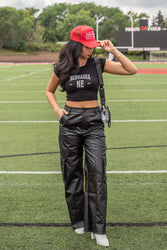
xmin=59 ymin=106 xmax=107 ymax=234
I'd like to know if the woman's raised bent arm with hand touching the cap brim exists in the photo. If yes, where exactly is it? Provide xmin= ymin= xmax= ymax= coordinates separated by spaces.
xmin=101 ymin=40 xmax=137 ymax=75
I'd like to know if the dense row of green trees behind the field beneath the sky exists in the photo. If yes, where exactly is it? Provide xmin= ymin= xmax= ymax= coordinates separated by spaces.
xmin=0 ymin=2 xmax=164 ymax=50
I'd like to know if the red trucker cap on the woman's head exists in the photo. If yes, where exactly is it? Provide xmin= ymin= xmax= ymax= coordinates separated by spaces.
xmin=70 ymin=25 xmax=100 ymax=48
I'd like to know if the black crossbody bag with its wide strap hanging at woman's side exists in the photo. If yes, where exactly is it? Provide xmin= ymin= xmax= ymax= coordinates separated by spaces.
xmin=94 ymin=58 xmax=111 ymax=128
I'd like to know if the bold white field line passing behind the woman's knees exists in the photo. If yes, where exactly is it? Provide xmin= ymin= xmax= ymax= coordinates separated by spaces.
xmin=0 ymin=170 xmax=167 ymax=174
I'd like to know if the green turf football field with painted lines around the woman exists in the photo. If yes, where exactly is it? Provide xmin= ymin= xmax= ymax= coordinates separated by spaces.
xmin=0 ymin=63 xmax=167 ymax=250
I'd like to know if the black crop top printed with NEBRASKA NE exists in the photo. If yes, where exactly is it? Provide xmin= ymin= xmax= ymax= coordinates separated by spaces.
xmin=54 ymin=57 xmax=106 ymax=102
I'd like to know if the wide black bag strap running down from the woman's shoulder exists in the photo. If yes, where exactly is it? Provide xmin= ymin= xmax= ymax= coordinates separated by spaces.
xmin=94 ymin=58 xmax=106 ymax=108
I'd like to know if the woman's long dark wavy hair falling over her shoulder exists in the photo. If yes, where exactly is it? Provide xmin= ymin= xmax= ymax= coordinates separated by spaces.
xmin=54 ymin=40 xmax=82 ymax=91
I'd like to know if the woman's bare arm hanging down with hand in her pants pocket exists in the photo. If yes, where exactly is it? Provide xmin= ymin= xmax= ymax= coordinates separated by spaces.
xmin=46 ymin=73 xmax=68 ymax=120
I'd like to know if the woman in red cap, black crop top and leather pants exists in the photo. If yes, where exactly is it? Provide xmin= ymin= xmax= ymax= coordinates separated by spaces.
xmin=46 ymin=25 xmax=137 ymax=247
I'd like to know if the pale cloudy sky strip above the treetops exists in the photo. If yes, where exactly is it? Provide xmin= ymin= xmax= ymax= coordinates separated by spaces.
xmin=0 ymin=0 xmax=167 ymax=19
